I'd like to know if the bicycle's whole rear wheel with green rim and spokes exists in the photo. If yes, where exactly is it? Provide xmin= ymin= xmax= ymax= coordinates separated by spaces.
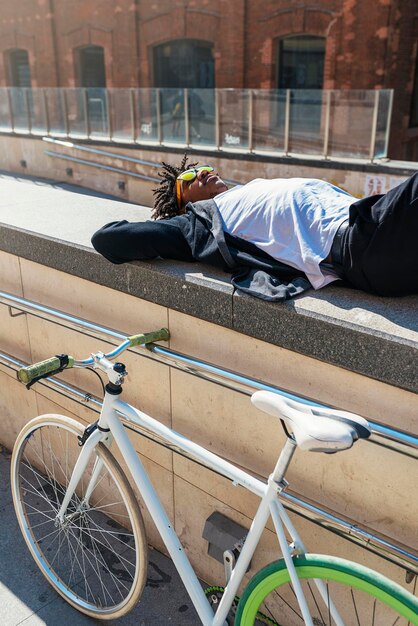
xmin=235 ymin=554 xmax=418 ymax=626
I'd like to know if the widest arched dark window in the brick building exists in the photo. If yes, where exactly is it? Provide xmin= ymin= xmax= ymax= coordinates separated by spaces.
xmin=153 ymin=39 xmax=215 ymax=89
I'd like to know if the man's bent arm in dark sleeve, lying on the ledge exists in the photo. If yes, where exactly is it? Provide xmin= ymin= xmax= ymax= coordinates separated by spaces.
xmin=91 ymin=216 xmax=194 ymax=263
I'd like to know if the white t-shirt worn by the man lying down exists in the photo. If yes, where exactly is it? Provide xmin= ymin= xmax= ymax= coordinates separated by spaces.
xmin=214 ymin=178 xmax=356 ymax=289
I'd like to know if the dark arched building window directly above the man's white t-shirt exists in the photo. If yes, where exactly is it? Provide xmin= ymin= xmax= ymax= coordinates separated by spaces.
xmin=277 ymin=35 xmax=325 ymax=89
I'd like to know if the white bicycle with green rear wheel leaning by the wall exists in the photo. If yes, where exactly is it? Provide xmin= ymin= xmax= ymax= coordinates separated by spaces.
xmin=11 ymin=329 xmax=418 ymax=626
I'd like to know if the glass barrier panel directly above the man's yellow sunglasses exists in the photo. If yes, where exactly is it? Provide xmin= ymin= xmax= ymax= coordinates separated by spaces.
xmin=188 ymin=89 xmax=216 ymax=148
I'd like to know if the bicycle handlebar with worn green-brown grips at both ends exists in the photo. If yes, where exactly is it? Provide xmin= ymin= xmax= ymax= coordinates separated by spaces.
xmin=17 ymin=328 xmax=170 ymax=387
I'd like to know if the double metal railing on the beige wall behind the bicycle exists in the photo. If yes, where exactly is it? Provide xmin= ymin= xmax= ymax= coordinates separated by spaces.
xmin=0 ymin=292 xmax=418 ymax=579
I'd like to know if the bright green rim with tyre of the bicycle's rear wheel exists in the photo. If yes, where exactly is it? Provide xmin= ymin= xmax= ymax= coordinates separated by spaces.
xmin=236 ymin=554 xmax=418 ymax=626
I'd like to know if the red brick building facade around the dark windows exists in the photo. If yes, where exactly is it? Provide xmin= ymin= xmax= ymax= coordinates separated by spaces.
xmin=0 ymin=0 xmax=418 ymax=158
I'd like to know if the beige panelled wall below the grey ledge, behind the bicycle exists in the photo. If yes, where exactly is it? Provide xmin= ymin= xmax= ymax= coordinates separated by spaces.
xmin=0 ymin=244 xmax=418 ymax=600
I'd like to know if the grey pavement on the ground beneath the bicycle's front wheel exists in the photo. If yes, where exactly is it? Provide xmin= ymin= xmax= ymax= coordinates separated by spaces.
xmin=0 ymin=446 xmax=200 ymax=626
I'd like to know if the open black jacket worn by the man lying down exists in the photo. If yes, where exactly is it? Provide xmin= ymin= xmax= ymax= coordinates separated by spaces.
xmin=92 ymin=200 xmax=311 ymax=302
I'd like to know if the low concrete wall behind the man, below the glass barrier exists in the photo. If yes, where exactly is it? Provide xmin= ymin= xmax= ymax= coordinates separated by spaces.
xmin=0 ymin=134 xmax=413 ymax=206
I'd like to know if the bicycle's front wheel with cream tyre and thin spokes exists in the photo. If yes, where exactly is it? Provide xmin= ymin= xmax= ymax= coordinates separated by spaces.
xmin=11 ymin=415 xmax=148 ymax=619
